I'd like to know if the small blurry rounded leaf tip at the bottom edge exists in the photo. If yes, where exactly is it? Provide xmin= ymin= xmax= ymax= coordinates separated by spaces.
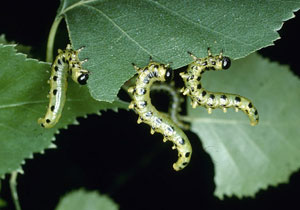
xmin=56 ymin=189 xmax=119 ymax=210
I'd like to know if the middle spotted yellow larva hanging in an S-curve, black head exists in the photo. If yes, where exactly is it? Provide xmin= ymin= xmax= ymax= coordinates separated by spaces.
xmin=128 ymin=61 xmax=192 ymax=171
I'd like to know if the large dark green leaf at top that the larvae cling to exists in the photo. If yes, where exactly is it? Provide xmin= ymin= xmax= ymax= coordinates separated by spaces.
xmin=58 ymin=0 xmax=300 ymax=102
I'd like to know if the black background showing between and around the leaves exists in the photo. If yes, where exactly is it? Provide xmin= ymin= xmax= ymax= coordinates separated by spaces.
xmin=0 ymin=1 xmax=300 ymax=210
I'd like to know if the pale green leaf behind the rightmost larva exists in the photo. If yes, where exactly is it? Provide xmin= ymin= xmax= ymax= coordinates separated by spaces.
xmin=187 ymin=54 xmax=300 ymax=198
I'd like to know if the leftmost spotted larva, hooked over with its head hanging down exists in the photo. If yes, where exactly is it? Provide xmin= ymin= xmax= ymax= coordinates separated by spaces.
xmin=38 ymin=44 xmax=89 ymax=128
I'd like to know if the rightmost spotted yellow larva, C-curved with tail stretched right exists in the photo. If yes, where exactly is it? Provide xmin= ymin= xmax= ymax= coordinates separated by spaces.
xmin=180 ymin=49 xmax=259 ymax=126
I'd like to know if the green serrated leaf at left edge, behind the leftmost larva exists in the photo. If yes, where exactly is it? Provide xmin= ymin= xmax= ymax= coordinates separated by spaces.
xmin=0 ymin=44 xmax=127 ymax=177
